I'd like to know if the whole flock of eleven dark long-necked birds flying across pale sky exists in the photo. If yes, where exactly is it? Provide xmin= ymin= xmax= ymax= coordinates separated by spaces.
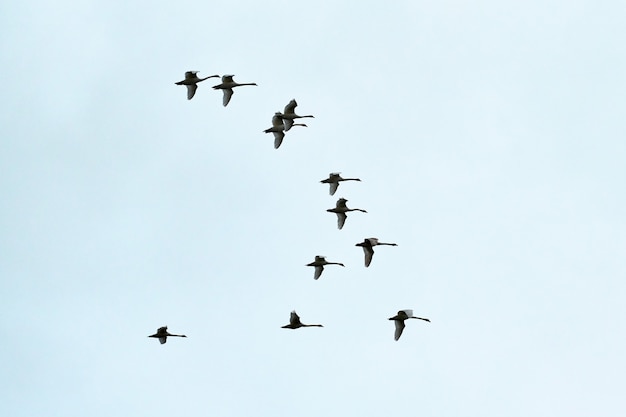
xmin=148 ymin=71 xmax=430 ymax=344
